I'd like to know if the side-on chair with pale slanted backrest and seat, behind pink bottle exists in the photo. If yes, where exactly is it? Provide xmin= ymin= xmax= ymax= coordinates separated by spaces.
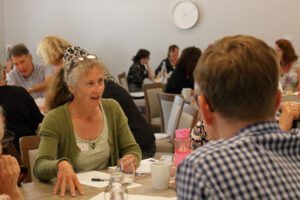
xmin=154 ymin=95 xmax=184 ymax=153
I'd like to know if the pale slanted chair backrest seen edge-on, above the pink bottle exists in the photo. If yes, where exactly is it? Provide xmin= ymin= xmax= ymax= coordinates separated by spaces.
xmin=167 ymin=95 xmax=184 ymax=143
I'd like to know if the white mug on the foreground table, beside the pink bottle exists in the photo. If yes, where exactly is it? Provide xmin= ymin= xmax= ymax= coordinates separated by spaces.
xmin=151 ymin=162 xmax=172 ymax=190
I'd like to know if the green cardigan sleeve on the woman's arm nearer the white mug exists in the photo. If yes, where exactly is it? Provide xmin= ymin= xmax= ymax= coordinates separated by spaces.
xmin=114 ymin=101 xmax=142 ymax=161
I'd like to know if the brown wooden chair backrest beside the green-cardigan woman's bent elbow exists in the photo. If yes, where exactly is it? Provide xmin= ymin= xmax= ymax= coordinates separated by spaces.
xmin=19 ymin=135 xmax=41 ymax=183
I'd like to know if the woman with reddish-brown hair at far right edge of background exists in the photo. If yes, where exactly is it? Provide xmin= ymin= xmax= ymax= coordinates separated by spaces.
xmin=275 ymin=39 xmax=300 ymax=92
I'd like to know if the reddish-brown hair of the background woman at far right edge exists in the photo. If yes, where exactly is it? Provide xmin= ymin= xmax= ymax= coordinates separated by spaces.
xmin=275 ymin=39 xmax=298 ymax=66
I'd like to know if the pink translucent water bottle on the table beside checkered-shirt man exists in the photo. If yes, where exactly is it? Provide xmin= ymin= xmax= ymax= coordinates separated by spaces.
xmin=174 ymin=129 xmax=192 ymax=167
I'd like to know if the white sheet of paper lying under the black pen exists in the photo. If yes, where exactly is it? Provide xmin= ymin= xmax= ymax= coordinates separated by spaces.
xmin=77 ymin=171 xmax=142 ymax=188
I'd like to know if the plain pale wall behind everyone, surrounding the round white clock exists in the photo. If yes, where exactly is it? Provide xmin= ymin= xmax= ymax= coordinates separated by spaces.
xmin=0 ymin=0 xmax=300 ymax=75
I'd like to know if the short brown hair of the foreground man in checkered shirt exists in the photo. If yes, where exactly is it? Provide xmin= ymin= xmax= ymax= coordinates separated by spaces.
xmin=194 ymin=35 xmax=279 ymax=121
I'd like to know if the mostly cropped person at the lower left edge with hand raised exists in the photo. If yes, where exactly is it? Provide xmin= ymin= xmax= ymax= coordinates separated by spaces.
xmin=0 ymin=106 xmax=23 ymax=200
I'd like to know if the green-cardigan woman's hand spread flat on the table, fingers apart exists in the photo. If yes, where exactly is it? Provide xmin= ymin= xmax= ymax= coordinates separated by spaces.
xmin=53 ymin=160 xmax=83 ymax=196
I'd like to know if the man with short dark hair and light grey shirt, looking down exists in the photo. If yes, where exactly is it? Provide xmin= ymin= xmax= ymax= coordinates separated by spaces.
xmin=7 ymin=44 xmax=53 ymax=99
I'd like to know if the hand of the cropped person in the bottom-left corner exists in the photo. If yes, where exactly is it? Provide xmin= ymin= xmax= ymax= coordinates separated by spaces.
xmin=0 ymin=155 xmax=23 ymax=200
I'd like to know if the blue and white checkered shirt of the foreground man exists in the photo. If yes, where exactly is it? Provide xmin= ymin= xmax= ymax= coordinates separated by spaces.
xmin=176 ymin=122 xmax=300 ymax=200
